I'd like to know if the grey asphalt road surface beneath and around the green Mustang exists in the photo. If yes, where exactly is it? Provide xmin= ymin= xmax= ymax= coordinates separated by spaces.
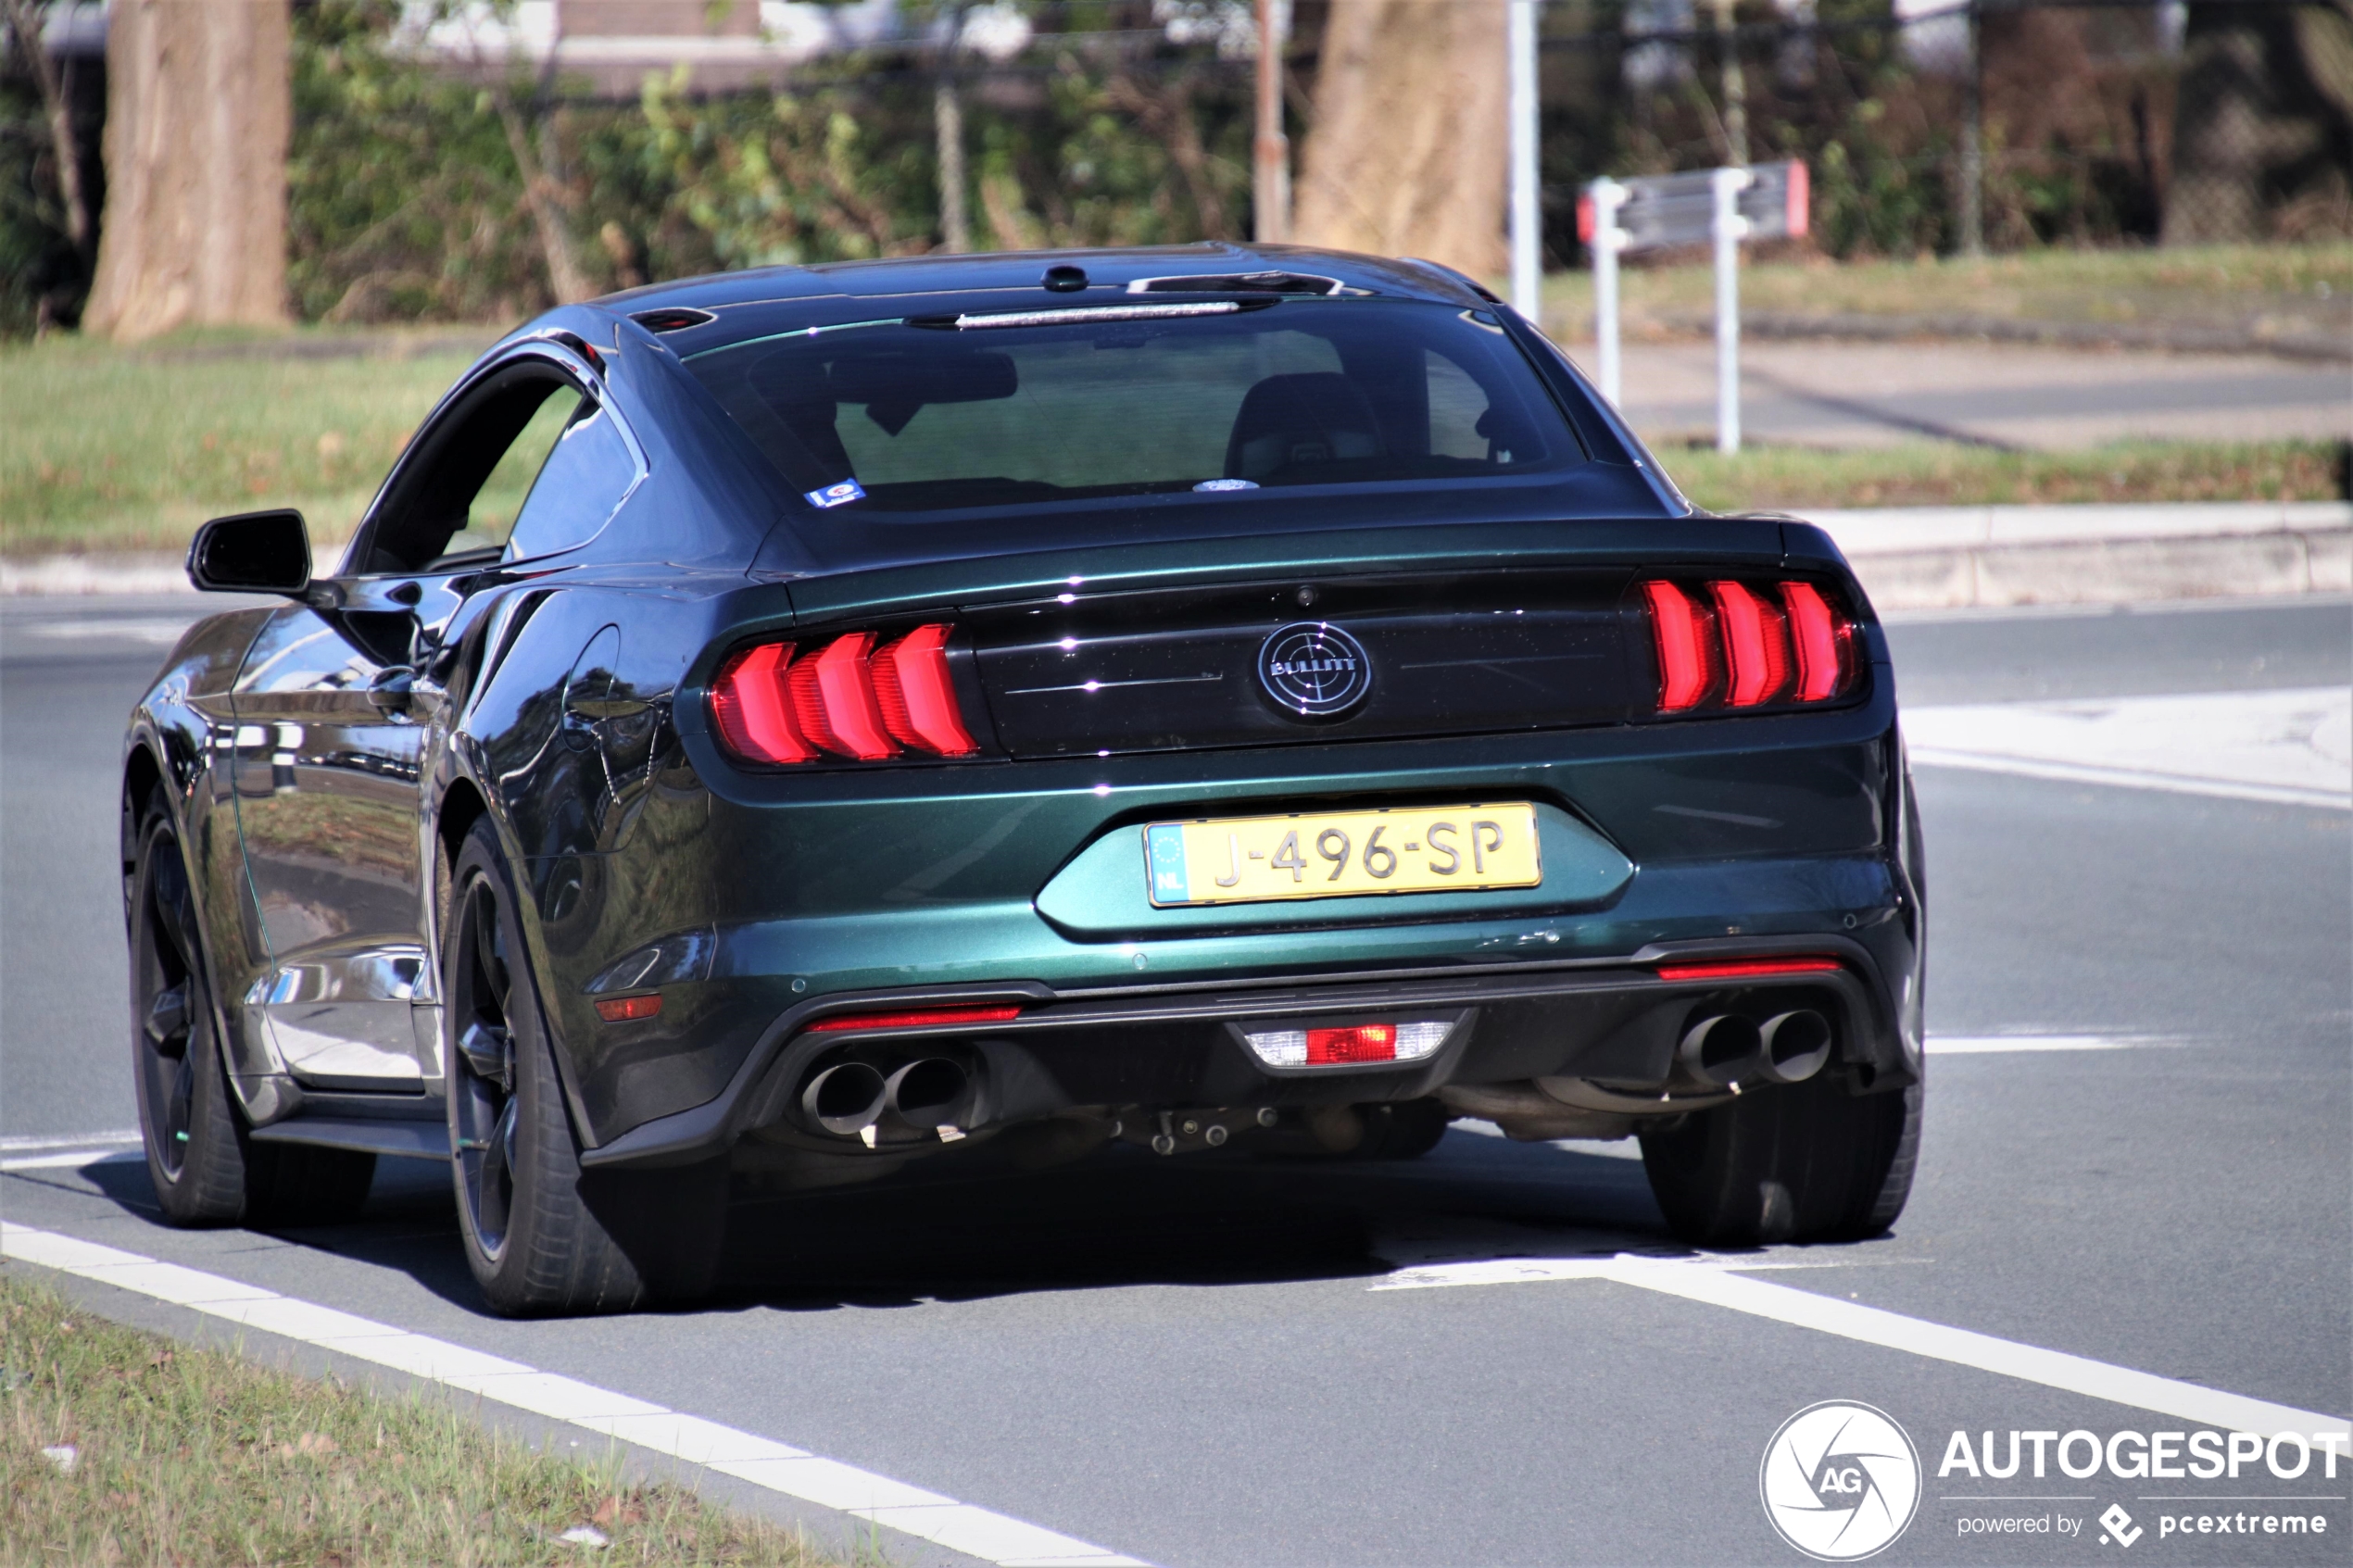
xmin=0 ymin=585 xmax=2353 ymax=1563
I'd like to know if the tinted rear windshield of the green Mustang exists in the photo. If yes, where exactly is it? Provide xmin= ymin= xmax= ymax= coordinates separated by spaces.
xmin=689 ymin=301 xmax=1583 ymax=520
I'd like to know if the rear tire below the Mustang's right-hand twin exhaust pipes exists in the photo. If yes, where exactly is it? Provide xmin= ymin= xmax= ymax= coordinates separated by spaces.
xmin=1642 ymin=1077 xmax=1922 ymax=1246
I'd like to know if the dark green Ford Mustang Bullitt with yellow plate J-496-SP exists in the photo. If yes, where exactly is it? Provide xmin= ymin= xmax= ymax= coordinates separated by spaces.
xmin=122 ymin=245 xmax=1922 ymax=1311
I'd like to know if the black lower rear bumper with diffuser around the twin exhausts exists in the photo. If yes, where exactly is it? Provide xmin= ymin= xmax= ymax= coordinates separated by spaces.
xmin=584 ymin=922 xmax=1920 ymax=1169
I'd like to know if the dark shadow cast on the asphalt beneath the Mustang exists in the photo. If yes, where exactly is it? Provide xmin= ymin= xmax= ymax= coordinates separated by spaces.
xmin=69 ymin=1128 xmax=1685 ymax=1311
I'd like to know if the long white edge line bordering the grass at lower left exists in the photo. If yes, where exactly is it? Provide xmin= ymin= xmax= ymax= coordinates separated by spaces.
xmin=0 ymin=1223 xmax=1143 ymax=1568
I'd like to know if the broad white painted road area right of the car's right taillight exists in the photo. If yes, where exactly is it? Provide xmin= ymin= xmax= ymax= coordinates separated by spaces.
xmin=1904 ymin=686 xmax=2353 ymax=811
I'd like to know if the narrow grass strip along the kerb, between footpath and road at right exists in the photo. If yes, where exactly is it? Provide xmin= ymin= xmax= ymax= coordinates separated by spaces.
xmin=1656 ymin=440 xmax=2348 ymax=512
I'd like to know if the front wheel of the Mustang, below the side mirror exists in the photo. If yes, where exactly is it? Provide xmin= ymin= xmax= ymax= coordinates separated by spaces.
xmin=130 ymin=787 xmax=376 ymax=1224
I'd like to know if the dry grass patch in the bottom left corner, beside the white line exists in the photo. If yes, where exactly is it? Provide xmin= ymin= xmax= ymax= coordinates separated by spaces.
xmin=0 ymin=1276 xmax=831 ymax=1568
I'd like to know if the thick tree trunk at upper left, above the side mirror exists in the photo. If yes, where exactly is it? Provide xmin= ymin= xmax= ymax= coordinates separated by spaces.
xmin=82 ymin=0 xmax=295 ymax=341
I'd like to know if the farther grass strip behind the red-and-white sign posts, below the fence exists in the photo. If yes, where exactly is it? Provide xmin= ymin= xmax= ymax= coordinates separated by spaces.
xmin=1543 ymin=242 xmax=2353 ymax=344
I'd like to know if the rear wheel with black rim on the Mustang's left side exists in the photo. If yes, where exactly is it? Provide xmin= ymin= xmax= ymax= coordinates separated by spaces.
xmin=443 ymin=821 xmax=727 ymax=1316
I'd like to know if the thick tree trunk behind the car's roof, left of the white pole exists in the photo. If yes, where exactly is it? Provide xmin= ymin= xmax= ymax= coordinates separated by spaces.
xmin=1291 ymin=0 xmax=1506 ymax=278
